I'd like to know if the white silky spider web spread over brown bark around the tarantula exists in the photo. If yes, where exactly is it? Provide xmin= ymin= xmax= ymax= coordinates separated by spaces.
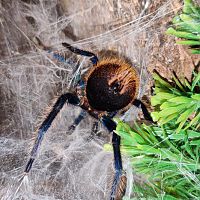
xmin=0 ymin=0 xmax=181 ymax=200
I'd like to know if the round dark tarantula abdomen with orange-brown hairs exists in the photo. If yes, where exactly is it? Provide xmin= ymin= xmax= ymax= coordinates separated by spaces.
xmin=86 ymin=60 xmax=139 ymax=112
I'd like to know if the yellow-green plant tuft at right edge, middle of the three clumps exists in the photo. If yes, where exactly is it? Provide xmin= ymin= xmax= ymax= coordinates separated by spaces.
xmin=151 ymin=73 xmax=200 ymax=133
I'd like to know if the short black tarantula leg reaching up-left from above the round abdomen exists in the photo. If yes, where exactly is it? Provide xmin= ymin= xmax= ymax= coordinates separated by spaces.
xmin=62 ymin=42 xmax=98 ymax=65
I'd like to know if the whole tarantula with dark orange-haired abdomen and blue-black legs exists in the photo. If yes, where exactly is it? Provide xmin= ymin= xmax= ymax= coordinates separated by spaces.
xmin=25 ymin=43 xmax=150 ymax=200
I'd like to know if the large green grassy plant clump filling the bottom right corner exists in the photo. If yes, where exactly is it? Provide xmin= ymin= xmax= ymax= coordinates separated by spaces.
xmin=111 ymin=121 xmax=200 ymax=199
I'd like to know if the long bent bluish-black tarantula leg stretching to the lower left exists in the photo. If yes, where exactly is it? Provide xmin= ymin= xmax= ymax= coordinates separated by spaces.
xmin=24 ymin=93 xmax=80 ymax=173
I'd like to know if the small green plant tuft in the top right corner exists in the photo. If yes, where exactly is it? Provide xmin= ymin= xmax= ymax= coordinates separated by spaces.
xmin=166 ymin=0 xmax=200 ymax=54
